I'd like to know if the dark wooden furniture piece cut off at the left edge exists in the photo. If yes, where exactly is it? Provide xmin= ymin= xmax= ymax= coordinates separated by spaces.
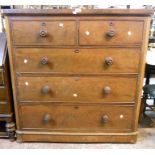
xmin=0 ymin=32 xmax=15 ymax=140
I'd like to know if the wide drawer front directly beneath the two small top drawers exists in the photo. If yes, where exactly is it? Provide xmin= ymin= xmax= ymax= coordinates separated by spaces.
xmin=15 ymin=48 xmax=140 ymax=74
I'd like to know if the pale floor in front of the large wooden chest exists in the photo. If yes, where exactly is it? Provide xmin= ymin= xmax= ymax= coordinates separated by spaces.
xmin=0 ymin=128 xmax=155 ymax=149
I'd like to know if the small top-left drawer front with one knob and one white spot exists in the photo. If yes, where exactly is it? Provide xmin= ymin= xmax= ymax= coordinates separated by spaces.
xmin=12 ymin=21 xmax=76 ymax=45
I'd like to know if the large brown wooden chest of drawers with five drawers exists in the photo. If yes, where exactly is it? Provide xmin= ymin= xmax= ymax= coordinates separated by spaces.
xmin=4 ymin=9 xmax=152 ymax=143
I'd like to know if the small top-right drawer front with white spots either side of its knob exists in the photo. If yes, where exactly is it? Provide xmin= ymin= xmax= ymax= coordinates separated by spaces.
xmin=79 ymin=20 xmax=143 ymax=45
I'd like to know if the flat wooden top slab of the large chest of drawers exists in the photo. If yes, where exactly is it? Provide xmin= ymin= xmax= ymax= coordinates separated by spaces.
xmin=2 ymin=9 xmax=154 ymax=16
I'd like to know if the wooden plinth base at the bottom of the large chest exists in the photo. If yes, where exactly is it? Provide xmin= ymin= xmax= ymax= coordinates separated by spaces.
xmin=17 ymin=131 xmax=137 ymax=143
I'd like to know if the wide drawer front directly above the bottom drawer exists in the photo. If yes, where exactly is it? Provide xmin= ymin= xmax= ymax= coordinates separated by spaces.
xmin=18 ymin=76 xmax=137 ymax=103
